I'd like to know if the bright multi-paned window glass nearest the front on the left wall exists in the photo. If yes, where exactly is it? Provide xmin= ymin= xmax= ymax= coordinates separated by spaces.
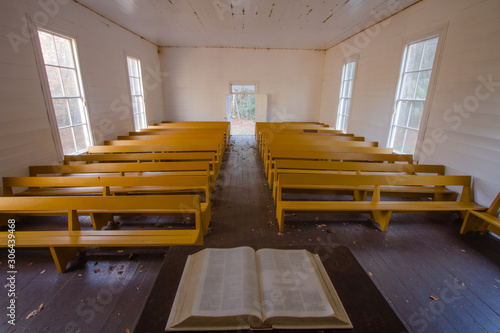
xmin=38 ymin=30 xmax=92 ymax=155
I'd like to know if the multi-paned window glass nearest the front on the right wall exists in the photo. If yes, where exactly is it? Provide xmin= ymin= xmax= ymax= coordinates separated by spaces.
xmin=389 ymin=37 xmax=439 ymax=154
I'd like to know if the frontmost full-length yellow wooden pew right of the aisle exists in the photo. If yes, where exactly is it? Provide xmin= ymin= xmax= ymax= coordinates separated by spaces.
xmin=276 ymin=174 xmax=484 ymax=232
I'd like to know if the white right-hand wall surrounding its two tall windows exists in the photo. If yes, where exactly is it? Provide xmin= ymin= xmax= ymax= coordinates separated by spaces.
xmin=319 ymin=0 xmax=500 ymax=205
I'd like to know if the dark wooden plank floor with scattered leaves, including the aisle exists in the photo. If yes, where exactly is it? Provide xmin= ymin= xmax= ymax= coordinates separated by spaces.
xmin=0 ymin=136 xmax=500 ymax=332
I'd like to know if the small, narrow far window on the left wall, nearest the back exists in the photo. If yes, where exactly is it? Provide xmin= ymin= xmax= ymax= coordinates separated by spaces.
xmin=127 ymin=57 xmax=147 ymax=131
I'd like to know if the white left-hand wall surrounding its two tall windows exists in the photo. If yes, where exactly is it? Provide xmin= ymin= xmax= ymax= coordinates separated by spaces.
xmin=0 ymin=0 xmax=163 ymax=180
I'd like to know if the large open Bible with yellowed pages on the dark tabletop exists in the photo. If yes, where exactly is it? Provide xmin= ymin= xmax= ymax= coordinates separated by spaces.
xmin=166 ymin=247 xmax=352 ymax=331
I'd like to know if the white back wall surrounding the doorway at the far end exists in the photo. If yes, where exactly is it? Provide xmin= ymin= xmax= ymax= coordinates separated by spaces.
xmin=160 ymin=47 xmax=324 ymax=121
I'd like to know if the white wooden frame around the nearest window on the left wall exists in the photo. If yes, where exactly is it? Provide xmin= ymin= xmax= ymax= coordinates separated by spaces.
xmin=32 ymin=25 xmax=95 ymax=161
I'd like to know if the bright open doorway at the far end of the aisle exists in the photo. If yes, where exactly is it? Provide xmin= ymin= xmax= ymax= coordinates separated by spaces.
xmin=226 ymin=84 xmax=256 ymax=135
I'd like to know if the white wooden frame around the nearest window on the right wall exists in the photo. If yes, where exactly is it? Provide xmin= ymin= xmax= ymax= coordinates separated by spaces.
xmin=386 ymin=23 xmax=448 ymax=158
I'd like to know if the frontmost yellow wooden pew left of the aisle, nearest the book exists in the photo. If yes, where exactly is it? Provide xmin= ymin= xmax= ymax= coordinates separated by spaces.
xmin=0 ymin=195 xmax=203 ymax=273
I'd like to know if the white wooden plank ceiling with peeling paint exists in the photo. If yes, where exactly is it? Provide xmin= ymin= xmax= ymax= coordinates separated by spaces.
xmin=74 ymin=0 xmax=421 ymax=50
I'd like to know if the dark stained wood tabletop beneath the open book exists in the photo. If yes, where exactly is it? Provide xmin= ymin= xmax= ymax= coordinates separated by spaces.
xmin=135 ymin=245 xmax=406 ymax=333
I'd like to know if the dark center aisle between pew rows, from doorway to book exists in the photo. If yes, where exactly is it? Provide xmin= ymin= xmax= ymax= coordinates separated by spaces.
xmin=204 ymin=135 xmax=290 ymax=247
